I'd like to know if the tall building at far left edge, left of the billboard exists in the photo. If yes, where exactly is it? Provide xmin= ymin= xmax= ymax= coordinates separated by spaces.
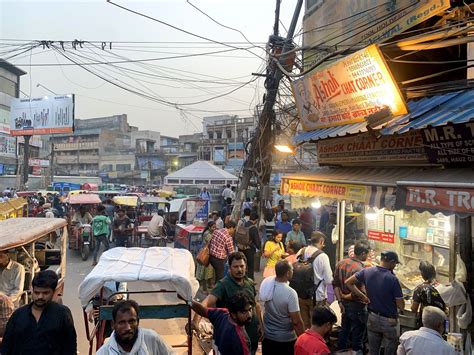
xmin=0 ymin=59 xmax=26 ymax=175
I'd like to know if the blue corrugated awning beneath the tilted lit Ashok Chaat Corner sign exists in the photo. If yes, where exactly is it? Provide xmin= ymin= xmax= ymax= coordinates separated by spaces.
xmin=293 ymin=90 xmax=474 ymax=145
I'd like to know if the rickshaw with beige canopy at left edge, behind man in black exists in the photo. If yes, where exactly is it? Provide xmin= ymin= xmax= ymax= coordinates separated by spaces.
xmin=0 ymin=217 xmax=68 ymax=305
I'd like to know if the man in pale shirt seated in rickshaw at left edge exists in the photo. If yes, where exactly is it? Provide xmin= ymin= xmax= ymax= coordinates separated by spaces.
xmin=0 ymin=250 xmax=25 ymax=306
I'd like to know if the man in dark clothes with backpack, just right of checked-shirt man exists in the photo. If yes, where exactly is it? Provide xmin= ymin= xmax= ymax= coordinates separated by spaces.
xmin=235 ymin=212 xmax=262 ymax=280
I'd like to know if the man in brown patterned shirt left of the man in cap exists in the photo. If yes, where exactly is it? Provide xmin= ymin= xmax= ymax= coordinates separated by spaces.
xmin=332 ymin=240 xmax=370 ymax=354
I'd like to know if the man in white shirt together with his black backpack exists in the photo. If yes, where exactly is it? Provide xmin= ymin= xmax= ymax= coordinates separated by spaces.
xmin=290 ymin=232 xmax=333 ymax=329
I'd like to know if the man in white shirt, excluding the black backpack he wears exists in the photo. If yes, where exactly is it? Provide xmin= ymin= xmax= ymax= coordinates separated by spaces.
xmin=296 ymin=232 xmax=333 ymax=327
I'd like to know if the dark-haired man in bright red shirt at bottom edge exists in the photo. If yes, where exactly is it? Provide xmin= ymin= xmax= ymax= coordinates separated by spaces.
xmin=295 ymin=306 xmax=337 ymax=355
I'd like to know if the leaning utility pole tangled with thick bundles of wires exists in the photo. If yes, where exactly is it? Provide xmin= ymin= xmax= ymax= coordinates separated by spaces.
xmin=232 ymin=0 xmax=303 ymax=220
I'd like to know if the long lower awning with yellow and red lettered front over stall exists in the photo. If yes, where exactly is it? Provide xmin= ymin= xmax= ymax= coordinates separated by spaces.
xmin=281 ymin=167 xmax=474 ymax=216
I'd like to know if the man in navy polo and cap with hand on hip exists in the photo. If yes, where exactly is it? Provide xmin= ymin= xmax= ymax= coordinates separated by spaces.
xmin=346 ymin=251 xmax=405 ymax=355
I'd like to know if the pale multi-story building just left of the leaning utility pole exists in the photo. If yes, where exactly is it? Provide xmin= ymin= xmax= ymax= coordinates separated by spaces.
xmin=198 ymin=115 xmax=256 ymax=171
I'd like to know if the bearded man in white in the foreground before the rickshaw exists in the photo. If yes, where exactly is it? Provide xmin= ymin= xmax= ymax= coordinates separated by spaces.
xmin=96 ymin=300 xmax=174 ymax=355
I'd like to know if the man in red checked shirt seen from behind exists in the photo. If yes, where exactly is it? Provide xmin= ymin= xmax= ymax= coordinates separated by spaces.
xmin=209 ymin=221 xmax=237 ymax=281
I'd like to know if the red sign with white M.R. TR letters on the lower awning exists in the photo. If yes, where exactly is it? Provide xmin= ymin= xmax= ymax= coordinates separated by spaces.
xmin=395 ymin=186 xmax=474 ymax=215
